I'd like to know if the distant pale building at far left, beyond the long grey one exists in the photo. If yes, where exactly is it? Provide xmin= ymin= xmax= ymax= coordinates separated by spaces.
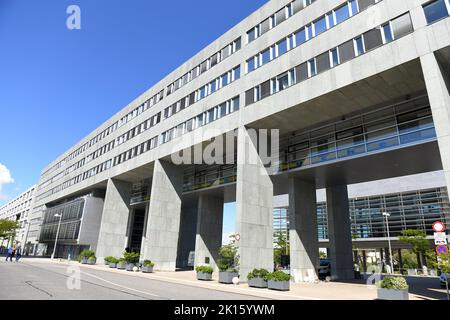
xmin=0 ymin=185 xmax=37 ymax=253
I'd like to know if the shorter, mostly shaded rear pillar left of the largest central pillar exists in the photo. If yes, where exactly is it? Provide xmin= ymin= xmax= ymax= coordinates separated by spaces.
xmin=195 ymin=194 xmax=223 ymax=270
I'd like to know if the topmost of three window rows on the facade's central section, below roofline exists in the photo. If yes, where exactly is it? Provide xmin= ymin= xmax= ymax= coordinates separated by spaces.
xmin=166 ymin=37 xmax=241 ymax=95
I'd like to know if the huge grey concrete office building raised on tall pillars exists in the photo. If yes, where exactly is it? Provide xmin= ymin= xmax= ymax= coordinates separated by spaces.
xmin=32 ymin=0 xmax=450 ymax=281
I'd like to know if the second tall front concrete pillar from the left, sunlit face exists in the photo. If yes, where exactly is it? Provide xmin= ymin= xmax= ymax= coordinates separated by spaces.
xmin=143 ymin=160 xmax=183 ymax=271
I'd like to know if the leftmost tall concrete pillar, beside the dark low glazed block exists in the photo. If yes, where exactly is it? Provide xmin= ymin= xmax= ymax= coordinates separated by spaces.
xmin=95 ymin=179 xmax=131 ymax=261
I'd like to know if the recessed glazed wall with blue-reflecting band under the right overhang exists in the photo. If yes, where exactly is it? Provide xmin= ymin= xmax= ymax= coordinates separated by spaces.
xmin=280 ymin=97 xmax=436 ymax=171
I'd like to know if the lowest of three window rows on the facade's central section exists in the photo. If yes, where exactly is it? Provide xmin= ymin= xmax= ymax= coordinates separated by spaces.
xmin=160 ymin=96 xmax=239 ymax=144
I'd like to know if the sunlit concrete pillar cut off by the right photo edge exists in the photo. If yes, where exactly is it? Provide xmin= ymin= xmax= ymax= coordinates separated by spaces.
xmin=419 ymin=53 xmax=450 ymax=192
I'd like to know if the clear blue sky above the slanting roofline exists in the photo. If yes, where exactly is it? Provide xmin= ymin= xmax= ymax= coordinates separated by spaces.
xmin=0 ymin=0 xmax=267 ymax=239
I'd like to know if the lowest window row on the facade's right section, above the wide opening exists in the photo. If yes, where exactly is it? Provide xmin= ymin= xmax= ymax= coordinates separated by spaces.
xmin=245 ymin=12 xmax=413 ymax=105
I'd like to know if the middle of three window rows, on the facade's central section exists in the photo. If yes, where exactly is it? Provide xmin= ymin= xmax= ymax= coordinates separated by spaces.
xmin=163 ymin=66 xmax=241 ymax=119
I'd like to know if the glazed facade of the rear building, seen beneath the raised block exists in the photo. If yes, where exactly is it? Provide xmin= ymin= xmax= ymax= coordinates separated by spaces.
xmin=273 ymin=187 xmax=450 ymax=240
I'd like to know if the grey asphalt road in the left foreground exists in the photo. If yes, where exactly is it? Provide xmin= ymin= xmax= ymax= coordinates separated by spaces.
xmin=0 ymin=257 xmax=266 ymax=300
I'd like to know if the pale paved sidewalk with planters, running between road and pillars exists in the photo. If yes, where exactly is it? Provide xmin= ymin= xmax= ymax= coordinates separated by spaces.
xmin=25 ymin=259 xmax=436 ymax=300
